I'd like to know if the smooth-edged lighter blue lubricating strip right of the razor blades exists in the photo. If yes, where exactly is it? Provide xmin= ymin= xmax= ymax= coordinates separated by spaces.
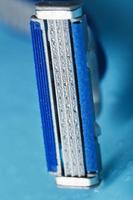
xmin=72 ymin=22 xmax=98 ymax=172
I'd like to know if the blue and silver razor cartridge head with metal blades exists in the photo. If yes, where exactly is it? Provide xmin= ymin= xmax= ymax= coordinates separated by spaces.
xmin=30 ymin=1 xmax=101 ymax=188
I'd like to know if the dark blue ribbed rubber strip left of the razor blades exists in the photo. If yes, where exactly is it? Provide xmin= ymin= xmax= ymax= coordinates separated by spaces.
xmin=30 ymin=21 xmax=57 ymax=172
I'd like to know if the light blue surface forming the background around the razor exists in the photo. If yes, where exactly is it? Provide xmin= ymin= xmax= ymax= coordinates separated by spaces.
xmin=0 ymin=0 xmax=133 ymax=200
